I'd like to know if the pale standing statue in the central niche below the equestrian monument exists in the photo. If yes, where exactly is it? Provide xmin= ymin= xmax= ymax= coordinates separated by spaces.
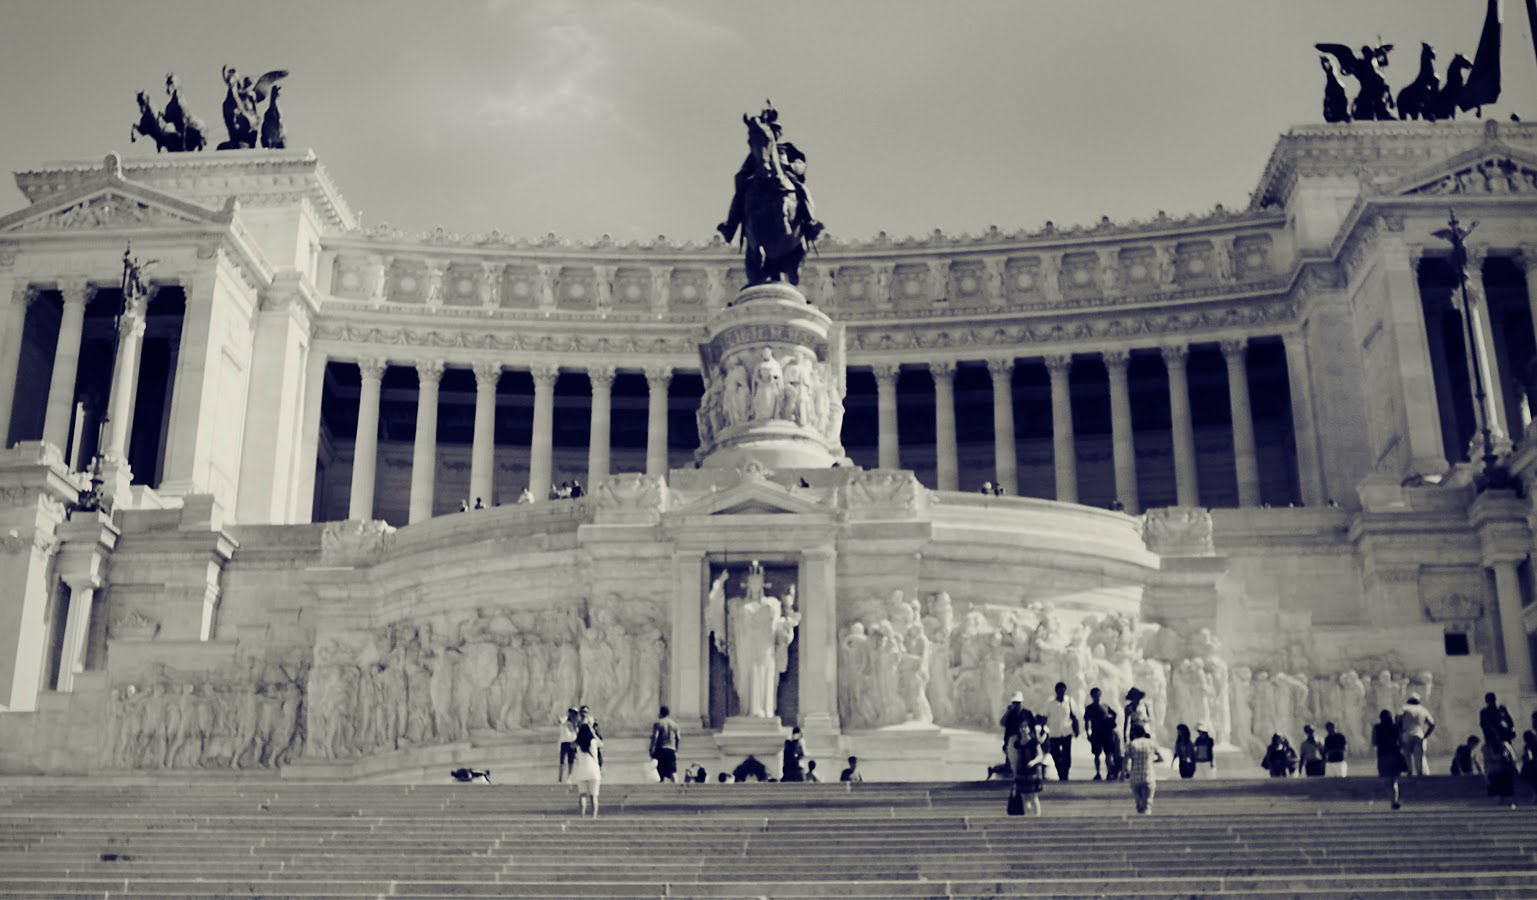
xmin=705 ymin=559 xmax=801 ymax=719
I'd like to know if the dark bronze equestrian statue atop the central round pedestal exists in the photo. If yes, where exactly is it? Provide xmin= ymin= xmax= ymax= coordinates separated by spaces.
xmin=716 ymin=106 xmax=822 ymax=286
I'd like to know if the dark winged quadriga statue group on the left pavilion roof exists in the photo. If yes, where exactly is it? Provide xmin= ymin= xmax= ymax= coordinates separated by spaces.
xmin=128 ymin=66 xmax=287 ymax=154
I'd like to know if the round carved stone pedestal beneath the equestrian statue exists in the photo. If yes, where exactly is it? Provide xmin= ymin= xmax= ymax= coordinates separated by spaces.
xmin=695 ymin=284 xmax=845 ymax=468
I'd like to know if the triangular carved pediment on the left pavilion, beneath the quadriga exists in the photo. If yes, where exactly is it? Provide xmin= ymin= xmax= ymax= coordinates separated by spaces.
xmin=0 ymin=175 xmax=227 ymax=233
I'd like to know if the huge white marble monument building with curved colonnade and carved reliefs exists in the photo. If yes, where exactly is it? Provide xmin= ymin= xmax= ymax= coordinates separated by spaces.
xmin=0 ymin=105 xmax=1537 ymax=782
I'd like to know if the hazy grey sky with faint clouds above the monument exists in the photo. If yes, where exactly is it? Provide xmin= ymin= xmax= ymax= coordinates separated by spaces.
xmin=0 ymin=0 xmax=1537 ymax=241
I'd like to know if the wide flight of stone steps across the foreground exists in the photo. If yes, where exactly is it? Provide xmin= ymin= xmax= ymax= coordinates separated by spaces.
xmin=0 ymin=777 xmax=1537 ymax=898
